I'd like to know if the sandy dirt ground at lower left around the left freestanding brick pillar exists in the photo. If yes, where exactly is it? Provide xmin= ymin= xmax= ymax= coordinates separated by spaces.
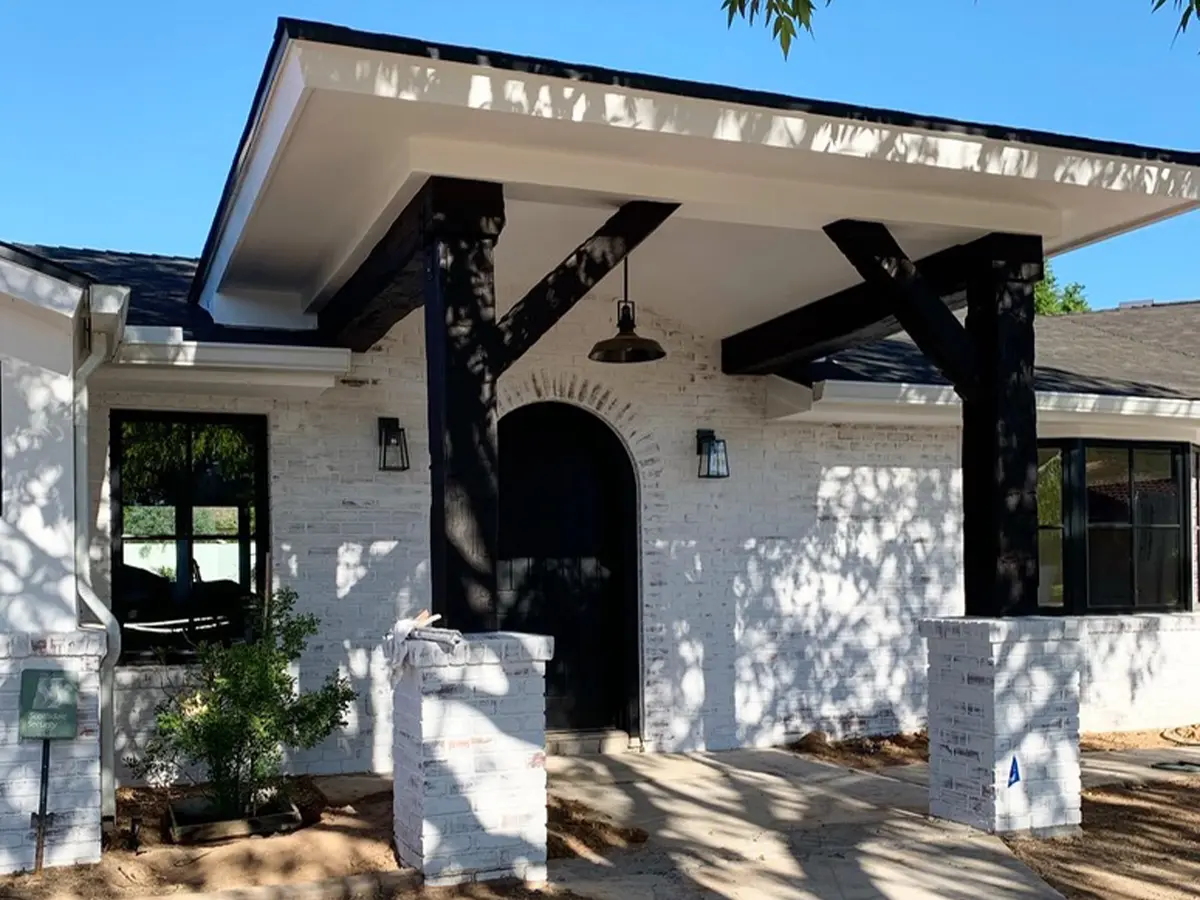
xmin=0 ymin=779 xmax=619 ymax=900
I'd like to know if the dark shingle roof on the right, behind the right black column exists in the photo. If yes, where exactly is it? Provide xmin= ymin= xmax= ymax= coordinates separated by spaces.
xmin=797 ymin=301 xmax=1200 ymax=400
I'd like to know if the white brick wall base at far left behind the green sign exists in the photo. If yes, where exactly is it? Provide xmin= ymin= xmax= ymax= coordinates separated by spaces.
xmin=0 ymin=631 xmax=106 ymax=874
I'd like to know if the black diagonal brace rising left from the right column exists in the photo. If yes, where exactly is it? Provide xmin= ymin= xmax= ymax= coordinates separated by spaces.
xmin=824 ymin=218 xmax=977 ymax=397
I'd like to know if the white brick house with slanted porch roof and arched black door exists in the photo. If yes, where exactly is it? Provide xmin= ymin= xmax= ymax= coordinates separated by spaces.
xmin=0 ymin=15 xmax=1200 ymax=854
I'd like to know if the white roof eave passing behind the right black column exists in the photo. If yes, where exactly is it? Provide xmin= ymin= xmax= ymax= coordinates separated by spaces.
xmin=767 ymin=376 xmax=1200 ymax=439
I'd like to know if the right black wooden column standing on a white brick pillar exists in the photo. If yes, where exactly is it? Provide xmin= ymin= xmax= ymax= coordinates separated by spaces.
xmin=962 ymin=234 xmax=1043 ymax=616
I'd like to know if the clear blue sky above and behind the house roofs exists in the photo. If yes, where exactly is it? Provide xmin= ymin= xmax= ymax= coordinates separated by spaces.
xmin=0 ymin=0 xmax=1200 ymax=306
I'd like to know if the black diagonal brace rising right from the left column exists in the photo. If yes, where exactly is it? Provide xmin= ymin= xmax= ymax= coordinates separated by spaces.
xmin=499 ymin=200 xmax=679 ymax=372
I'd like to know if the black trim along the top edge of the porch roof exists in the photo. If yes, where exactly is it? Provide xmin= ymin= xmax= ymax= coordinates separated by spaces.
xmin=188 ymin=17 xmax=1200 ymax=302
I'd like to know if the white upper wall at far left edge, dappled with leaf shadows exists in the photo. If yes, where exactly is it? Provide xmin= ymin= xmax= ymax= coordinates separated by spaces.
xmin=0 ymin=359 xmax=76 ymax=632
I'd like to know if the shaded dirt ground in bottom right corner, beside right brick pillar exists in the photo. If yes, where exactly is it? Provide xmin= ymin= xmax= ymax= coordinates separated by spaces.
xmin=1008 ymin=778 xmax=1200 ymax=900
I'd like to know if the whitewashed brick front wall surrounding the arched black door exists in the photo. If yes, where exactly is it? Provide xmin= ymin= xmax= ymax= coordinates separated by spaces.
xmin=90 ymin=292 xmax=962 ymax=772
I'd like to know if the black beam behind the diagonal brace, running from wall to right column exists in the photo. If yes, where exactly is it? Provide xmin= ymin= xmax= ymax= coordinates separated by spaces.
xmin=721 ymin=241 xmax=978 ymax=374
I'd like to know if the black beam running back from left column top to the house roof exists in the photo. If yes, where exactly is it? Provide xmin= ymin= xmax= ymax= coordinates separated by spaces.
xmin=317 ymin=178 xmax=503 ymax=353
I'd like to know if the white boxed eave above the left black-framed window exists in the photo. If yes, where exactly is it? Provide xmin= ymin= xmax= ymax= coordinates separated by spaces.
xmin=96 ymin=326 xmax=350 ymax=397
